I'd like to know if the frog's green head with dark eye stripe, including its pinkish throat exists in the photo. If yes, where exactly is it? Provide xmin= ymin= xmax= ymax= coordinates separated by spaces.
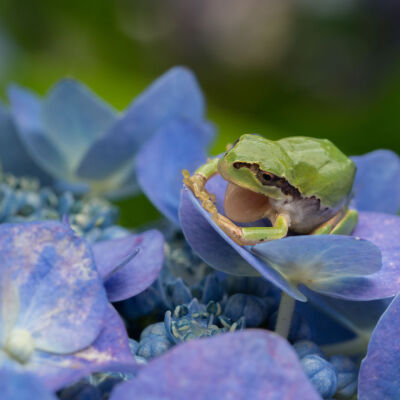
xmin=218 ymin=134 xmax=299 ymax=222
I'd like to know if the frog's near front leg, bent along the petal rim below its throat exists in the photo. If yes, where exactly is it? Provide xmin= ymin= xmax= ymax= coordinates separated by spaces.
xmin=212 ymin=213 xmax=289 ymax=246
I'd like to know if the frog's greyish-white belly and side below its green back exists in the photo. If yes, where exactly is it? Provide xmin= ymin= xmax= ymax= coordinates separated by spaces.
xmin=270 ymin=197 xmax=339 ymax=234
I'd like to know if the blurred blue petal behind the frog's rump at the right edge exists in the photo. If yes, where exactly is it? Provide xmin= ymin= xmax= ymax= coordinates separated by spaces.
xmin=352 ymin=150 xmax=400 ymax=214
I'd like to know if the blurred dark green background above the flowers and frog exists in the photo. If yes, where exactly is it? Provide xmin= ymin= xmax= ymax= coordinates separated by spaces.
xmin=0 ymin=0 xmax=400 ymax=222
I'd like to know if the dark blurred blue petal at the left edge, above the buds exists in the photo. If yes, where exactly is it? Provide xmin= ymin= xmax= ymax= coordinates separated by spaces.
xmin=0 ymin=104 xmax=51 ymax=184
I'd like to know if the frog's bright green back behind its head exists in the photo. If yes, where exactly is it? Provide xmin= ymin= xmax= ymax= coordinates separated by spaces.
xmin=277 ymin=136 xmax=356 ymax=207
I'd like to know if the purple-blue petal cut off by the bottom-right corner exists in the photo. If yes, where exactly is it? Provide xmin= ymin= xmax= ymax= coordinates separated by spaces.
xmin=358 ymin=296 xmax=400 ymax=400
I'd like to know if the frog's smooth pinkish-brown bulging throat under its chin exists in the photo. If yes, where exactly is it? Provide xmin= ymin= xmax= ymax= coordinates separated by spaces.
xmin=224 ymin=182 xmax=271 ymax=223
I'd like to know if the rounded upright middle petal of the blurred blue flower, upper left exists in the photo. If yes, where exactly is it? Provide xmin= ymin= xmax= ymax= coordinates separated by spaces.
xmin=43 ymin=79 xmax=117 ymax=170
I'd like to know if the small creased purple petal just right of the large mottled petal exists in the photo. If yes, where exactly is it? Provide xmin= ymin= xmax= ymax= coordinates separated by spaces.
xmin=93 ymin=230 xmax=164 ymax=301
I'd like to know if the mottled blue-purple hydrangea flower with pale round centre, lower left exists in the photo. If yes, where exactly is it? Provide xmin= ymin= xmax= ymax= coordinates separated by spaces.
xmin=0 ymin=222 xmax=135 ymax=389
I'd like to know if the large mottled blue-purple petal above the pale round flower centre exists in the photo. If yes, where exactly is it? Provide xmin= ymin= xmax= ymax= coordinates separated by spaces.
xmin=0 ymin=222 xmax=107 ymax=353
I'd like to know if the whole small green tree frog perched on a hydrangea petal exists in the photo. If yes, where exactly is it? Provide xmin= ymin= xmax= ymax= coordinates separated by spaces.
xmin=183 ymin=134 xmax=358 ymax=245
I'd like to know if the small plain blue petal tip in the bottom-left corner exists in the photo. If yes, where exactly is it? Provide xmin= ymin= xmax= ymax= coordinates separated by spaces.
xmin=0 ymin=368 xmax=57 ymax=400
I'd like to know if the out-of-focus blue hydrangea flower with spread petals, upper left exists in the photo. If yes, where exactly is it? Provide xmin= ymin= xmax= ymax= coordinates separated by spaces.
xmin=0 ymin=67 xmax=212 ymax=197
